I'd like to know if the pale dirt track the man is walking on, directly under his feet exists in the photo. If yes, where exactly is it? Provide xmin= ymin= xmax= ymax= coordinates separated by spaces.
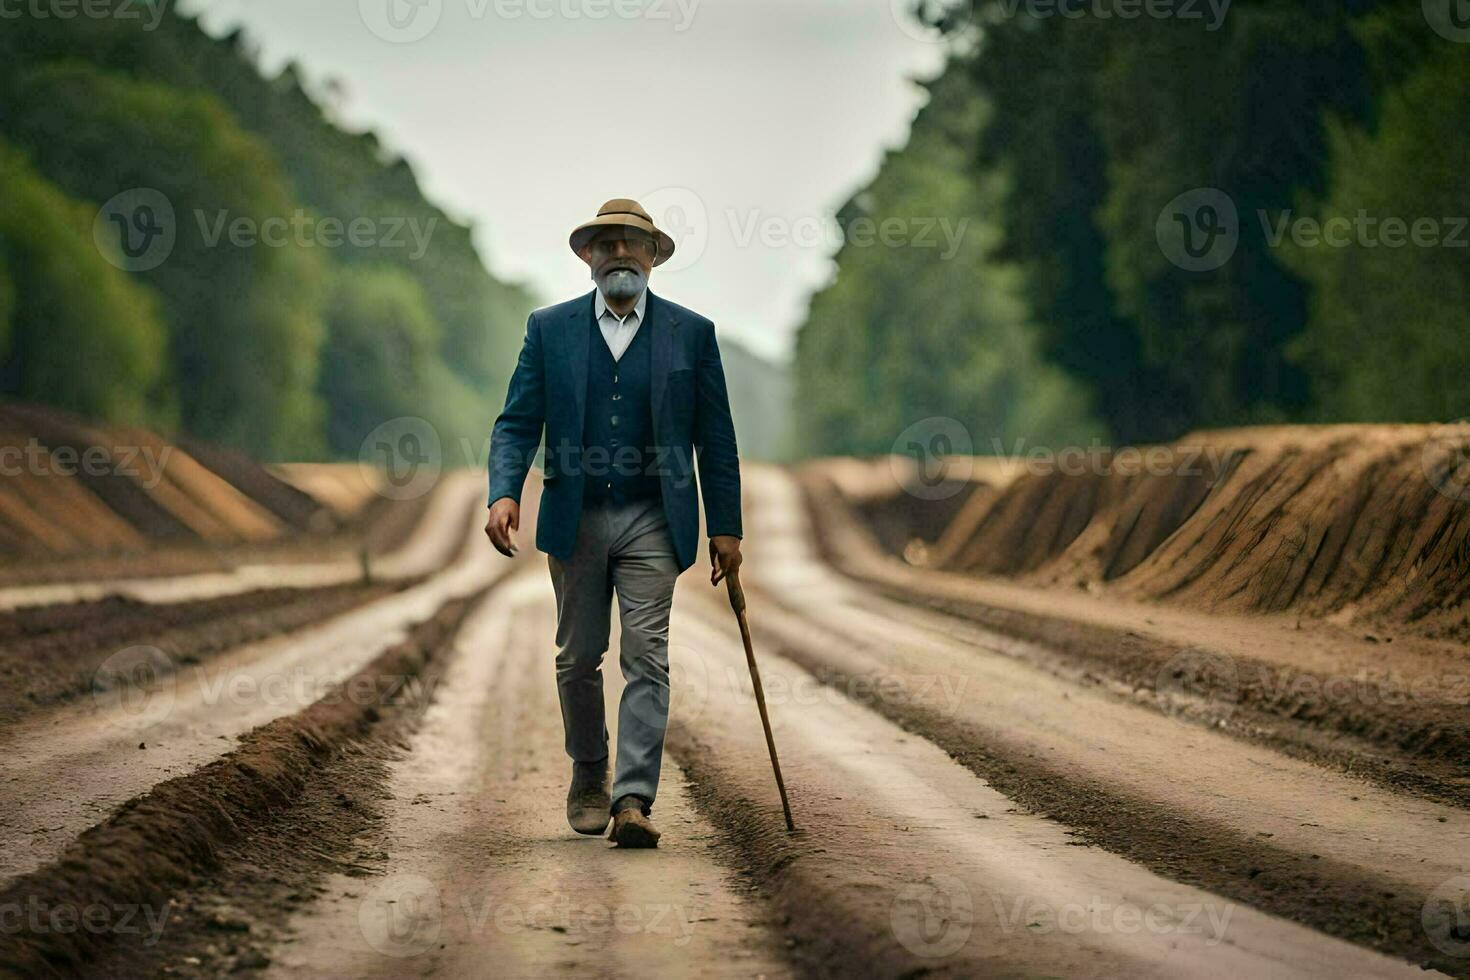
xmin=263 ymin=569 xmax=789 ymax=977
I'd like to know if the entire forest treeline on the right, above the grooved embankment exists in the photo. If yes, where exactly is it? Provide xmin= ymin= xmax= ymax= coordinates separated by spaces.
xmin=794 ymin=0 xmax=1470 ymax=453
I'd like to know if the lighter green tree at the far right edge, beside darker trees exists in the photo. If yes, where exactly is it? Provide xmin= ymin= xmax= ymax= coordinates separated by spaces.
xmin=1285 ymin=46 xmax=1470 ymax=422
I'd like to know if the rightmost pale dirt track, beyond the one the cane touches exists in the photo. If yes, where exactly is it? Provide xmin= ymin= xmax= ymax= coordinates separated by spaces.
xmin=729 ymin=475 xmax=1470 ymax=970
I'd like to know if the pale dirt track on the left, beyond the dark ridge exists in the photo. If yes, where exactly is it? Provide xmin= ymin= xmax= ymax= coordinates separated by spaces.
xmin=0 ymin=491 xmax=513 ymax=882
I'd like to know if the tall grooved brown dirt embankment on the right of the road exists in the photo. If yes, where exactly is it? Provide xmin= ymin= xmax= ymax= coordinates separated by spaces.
xmin=833 ymin=425 xmax=1470 ymax=642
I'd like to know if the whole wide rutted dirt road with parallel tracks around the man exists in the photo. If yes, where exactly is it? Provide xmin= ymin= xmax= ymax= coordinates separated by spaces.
xmin=0 ymin=467 xmax=1470 ymax=977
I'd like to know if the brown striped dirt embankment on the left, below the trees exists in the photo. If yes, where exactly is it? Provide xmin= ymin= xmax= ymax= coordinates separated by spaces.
xmin=0 ymin=403 xmax=441 ymax=585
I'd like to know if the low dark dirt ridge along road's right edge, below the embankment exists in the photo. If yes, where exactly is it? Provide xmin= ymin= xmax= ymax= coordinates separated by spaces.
xmin=798 ymin=470 xmax=1470 ymax=807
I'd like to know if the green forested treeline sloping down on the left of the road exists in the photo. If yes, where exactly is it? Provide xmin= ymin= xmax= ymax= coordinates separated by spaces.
xmin=0 ymin=0 xmax=532 ymax=458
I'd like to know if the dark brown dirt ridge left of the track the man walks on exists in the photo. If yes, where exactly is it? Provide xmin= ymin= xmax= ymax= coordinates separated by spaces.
xmin=0 ymin=586 xmax=492 ymax=977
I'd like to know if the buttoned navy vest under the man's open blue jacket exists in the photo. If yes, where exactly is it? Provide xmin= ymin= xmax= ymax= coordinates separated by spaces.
xmin=582 ymin=315 xmax=663 ymax=504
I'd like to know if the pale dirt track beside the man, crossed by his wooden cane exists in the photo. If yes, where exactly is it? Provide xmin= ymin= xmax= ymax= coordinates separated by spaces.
xmin=661 ymin=605 xmax=1423 ymax=979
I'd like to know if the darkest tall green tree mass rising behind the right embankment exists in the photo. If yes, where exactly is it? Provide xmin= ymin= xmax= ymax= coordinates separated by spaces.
xmin=975 ymin=0 xmax=1374 ymax=441
